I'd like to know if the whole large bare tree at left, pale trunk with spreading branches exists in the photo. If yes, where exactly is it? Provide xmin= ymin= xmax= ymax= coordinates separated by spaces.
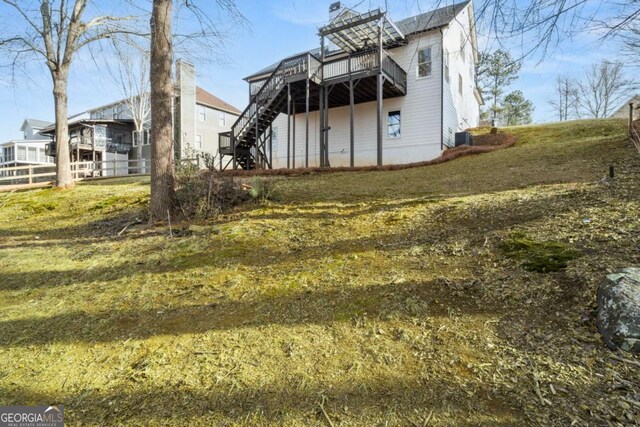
xmin=0 ymin=0 xmax=141 ymax=187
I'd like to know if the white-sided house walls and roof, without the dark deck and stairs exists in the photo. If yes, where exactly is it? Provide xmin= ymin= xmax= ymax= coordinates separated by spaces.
xmin=221 ymin=1 xmax=482 ymax=168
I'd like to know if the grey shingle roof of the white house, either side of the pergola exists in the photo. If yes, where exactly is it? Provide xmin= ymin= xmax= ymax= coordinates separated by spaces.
xmin=244 ymin=0 xmax=471 ymax=80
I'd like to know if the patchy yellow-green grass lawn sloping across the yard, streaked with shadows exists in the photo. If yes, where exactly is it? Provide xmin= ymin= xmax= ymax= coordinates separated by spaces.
xmin=0 ymin=120 xmax=640 ymax=426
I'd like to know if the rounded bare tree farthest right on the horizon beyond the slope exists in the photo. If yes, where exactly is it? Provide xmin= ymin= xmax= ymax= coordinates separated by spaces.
xmin=580 ymin=61 xmax=633 ymax=119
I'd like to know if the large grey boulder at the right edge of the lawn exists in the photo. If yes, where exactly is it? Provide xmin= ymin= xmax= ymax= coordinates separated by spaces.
xmin=598 ymin=268 xmax=640 ymax=353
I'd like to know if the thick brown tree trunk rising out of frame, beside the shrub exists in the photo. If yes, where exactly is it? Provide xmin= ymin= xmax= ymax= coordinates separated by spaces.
xmin=149 ymin=0 xmax=174 ymax=222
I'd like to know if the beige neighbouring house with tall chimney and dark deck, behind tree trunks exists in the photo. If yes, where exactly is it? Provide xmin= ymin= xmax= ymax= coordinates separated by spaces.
xmin=42 ymin=60 xmax=240 ymax=175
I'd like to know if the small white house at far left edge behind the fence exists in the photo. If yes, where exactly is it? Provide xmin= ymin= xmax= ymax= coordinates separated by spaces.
xmin=0 ymin=119 xmax=54 ymax=175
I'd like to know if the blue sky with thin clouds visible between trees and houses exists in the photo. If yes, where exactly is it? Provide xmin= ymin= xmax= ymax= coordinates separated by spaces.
xmin=0 ymin=0 xmax=630 ymax=141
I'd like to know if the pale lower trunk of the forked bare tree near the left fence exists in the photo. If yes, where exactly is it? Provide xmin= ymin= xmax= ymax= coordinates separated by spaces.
xmin=53 ymin=75 xmax=74 ymax=188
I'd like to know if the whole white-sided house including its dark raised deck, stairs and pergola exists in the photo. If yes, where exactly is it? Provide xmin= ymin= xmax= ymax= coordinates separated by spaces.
xmin=220 ymin=1 xmax=482 ymax=169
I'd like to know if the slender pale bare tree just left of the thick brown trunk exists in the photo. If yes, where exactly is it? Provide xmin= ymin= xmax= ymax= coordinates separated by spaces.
xmin=109 ymin=38 xmax=151 ymax=171
